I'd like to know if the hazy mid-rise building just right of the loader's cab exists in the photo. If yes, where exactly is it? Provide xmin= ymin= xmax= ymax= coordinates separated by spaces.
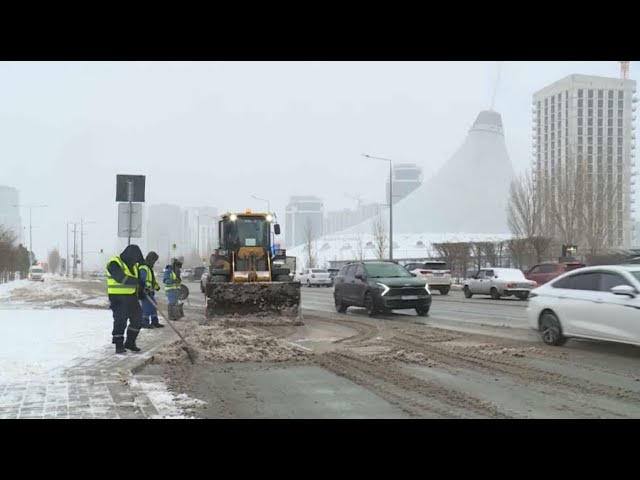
xmin=285 ymin=196 xmax=324 ymax=248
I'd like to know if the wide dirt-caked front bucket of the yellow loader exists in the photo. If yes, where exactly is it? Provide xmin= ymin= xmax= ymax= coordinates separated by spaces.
xmin=206 ymin=282 xmax=302 ymax=325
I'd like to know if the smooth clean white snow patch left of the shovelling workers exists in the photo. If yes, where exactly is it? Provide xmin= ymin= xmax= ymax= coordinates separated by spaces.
xmin=0 ymin=304 xmax=113 ymax=383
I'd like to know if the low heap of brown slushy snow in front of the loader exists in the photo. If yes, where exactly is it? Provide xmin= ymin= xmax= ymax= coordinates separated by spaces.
xmin=154 ymin=325 xmax=306 ymax=365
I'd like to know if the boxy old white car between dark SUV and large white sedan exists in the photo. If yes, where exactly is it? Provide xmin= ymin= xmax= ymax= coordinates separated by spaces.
xmin=463 ymin=268 xmax=536 ymax=300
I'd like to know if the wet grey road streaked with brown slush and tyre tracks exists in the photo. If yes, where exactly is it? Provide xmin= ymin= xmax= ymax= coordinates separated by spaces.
xmin=143 ymin=284 xmax=640 ymax=418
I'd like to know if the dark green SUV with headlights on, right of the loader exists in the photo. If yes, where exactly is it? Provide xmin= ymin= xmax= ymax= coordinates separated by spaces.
xmin=333 ymin=261 xmax=431 ymax=317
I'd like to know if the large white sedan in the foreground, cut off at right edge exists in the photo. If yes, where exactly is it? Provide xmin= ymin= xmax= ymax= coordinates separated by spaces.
xmin=527 ymin=265 xmax=640 ymax=345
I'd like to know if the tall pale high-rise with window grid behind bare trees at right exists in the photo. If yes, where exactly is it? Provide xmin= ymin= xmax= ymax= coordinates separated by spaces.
xmin=533 ymin=75 xmax=637 ymax=248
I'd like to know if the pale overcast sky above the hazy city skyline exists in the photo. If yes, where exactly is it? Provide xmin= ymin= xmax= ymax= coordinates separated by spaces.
xmin=0 ymin=61 xmax=634 ymax=266
